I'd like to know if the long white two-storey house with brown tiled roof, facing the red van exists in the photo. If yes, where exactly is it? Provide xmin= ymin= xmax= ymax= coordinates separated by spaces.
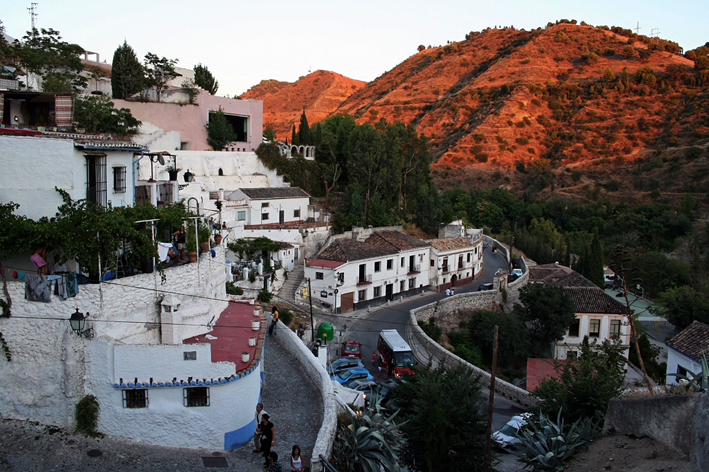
xmin=305 ymin=227 xmax=430 ymax=313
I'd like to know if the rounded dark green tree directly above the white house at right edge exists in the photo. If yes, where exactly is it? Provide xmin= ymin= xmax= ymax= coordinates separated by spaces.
xmin=650 ymin=285 xmax=709 ymax=332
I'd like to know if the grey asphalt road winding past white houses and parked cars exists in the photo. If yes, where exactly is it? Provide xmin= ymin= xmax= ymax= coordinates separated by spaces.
xmin=338 ymin=248 xmax=524 ymax=431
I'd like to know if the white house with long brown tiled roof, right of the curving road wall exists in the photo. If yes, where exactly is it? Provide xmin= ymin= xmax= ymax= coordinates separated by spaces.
xmin=529 ymin=264 xmax=630 ymax=359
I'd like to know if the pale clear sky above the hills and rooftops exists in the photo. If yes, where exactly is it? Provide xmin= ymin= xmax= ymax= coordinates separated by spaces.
xmin=0 ymin=0 xmax=709 ymax=96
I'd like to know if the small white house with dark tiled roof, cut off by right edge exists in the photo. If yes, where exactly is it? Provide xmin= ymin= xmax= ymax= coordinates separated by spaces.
xmin=665 ymin=321 xmax=709 ymax=385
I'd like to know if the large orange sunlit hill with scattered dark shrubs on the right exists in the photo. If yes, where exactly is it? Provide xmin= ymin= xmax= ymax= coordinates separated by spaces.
xmin=332 ymin=23 xmax=709 ymax=201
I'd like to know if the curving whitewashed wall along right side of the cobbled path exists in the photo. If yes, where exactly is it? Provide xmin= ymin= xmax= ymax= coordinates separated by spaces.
xmin=276 ymin=321 xmax=340 ymax=471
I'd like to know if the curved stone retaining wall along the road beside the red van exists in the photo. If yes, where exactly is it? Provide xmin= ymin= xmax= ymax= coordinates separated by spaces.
xmin=406 ymin=291 xmax=536 ymax=408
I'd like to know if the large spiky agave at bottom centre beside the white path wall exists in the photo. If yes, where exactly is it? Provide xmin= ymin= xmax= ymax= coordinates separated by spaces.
xmin=332 ymin=390 xmax=401 ymax=472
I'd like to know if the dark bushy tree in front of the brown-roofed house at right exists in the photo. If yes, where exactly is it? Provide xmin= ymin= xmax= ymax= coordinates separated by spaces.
xmin=532 ymin=337 xmax=625 ymax=422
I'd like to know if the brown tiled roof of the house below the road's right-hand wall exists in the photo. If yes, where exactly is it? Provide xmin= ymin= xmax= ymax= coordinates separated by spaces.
xmin=529 ymin=264 xmax=628 ymax=315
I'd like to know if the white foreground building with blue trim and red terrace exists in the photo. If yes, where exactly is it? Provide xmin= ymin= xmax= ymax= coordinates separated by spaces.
xmin=0 ymin=247 xmax=265 ymax=449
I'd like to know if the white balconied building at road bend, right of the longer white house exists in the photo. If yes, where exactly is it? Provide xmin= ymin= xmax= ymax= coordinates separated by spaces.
xmin=428 ymin=235 xmax=483 ymax=291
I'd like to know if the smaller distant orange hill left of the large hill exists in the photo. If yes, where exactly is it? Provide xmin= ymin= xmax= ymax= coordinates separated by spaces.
xmin=241 ymin=70 xmax=365 ymax=140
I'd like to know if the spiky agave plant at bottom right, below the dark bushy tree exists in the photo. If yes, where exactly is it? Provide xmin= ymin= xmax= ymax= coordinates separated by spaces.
xmin=512 ymin=410 xmax=584 ymax=470
